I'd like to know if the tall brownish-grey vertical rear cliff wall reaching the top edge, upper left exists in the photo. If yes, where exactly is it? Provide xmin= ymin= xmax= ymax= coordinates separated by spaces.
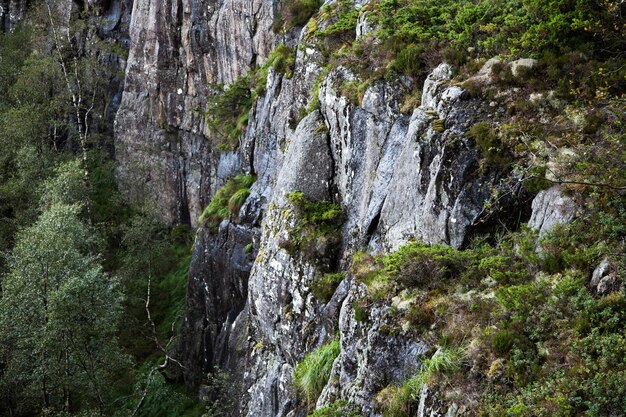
xmin=115 ymin=0 xmax=275 ymax=223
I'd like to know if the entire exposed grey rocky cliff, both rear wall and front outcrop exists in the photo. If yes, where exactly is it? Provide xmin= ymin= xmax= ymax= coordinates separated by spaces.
xmin=115 ymin=0 xmax=572 ymax=417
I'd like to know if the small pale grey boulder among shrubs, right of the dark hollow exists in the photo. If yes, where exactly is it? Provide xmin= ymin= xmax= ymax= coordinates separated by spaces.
xmin=528 ymin=185 xmax=578 ymax=236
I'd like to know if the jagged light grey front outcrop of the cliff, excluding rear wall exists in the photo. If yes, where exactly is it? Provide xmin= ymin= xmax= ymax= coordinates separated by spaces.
xmin=172 ymin=60 xmax=520 ymax=417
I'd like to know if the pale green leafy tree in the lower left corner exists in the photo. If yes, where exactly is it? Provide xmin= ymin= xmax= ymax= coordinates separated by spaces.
xmin=0 ymin=204 xmax=128 ymax=413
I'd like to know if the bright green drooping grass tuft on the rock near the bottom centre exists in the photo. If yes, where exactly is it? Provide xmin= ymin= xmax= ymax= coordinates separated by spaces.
xmin=293 ymin=339 xmax=341 ymax=405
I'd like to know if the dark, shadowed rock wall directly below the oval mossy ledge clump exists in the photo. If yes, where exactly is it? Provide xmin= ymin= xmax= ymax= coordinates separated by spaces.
xmin=177 ymin=221 xmax=257 ymax=385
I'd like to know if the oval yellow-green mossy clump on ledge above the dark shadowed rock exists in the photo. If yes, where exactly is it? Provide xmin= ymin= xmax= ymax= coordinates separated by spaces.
xmin=198 ymin=174 xmax=256 ymax=230
